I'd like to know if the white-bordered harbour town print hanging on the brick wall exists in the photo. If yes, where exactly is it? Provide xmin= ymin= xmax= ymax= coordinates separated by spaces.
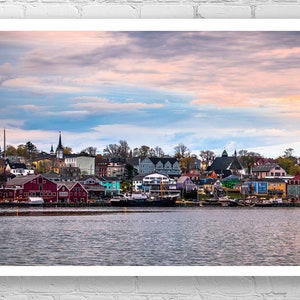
xmin=0 ymin=20 xmax=300 ymax=276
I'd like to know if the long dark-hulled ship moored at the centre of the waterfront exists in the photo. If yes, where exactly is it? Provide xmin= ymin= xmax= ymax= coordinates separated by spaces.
xmin=110 ymin=194 xmax=178 ymax=207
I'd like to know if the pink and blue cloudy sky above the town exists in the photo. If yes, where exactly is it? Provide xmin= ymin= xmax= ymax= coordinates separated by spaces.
xmin=0 ymin=31 xmax=300 ymax=158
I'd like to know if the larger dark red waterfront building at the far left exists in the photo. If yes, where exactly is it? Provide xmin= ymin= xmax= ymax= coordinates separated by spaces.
xmin=0 ymin=175 xmax=57 ymax=203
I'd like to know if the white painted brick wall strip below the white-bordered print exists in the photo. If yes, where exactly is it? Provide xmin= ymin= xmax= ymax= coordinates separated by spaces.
xmin=0 ymin=276 xmax=300 ymax=300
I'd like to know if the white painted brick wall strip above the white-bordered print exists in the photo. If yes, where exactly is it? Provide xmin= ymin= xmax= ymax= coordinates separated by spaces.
xmin=0 ymin=0 xmax=300 ymax=19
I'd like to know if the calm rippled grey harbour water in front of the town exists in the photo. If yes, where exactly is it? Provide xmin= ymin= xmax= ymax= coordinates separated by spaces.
xmin=0 ymin=208 xmax=300 ymax=266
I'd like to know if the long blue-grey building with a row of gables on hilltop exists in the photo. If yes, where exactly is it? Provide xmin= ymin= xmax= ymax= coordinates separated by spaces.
xmin=138 ymin=157 xmax=181 ymax=177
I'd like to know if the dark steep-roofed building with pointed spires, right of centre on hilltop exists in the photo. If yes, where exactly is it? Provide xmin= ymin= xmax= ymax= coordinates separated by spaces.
xmin=207 ymin=150 xmax=245 ymax=178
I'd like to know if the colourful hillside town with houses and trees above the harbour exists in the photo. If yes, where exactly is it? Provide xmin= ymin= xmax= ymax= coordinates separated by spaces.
xmin=0 ymin=133 xmax=300 ymax=206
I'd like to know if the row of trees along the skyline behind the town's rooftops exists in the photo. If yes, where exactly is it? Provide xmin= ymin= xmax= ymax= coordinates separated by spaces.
xmin=6 ymin=140 xmax=300 ymax=175
